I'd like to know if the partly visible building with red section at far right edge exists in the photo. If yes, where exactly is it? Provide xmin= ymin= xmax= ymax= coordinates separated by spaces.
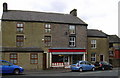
xmin=109 ymin=35 xmax=120 ymax=67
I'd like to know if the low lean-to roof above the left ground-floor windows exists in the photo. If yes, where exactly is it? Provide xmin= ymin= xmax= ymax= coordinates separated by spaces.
xmin=1 ymin=47 xmax=44 ymax=52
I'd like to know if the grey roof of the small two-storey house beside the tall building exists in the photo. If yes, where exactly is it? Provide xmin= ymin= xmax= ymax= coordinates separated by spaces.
xmin=87 ymin=29 xmax=108 ymax=37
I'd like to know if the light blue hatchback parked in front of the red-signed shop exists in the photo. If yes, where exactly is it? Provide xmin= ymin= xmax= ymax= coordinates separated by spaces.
xmin=70 ymin=61 xmax=95 ymax=72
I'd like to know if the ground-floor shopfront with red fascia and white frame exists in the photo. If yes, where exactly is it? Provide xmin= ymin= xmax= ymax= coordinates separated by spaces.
xmin=49 ymin=48 xmax=86 ymax=68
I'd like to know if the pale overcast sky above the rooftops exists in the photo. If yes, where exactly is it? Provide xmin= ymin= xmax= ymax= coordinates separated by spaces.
xmin=0 ymin=0 xmax=120 ymax=35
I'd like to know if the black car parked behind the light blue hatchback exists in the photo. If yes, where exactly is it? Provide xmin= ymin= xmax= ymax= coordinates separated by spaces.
xmin=94 ymin=61 xmax=113 ymax=70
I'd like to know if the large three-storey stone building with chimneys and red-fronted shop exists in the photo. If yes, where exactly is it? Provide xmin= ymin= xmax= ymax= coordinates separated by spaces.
xmin=1 ymin=3 xmax=87 ymax=69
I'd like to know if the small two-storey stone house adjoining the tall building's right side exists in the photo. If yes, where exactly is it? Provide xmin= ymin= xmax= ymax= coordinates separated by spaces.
xmin=87 ymin=29 xmax=109 ymax=63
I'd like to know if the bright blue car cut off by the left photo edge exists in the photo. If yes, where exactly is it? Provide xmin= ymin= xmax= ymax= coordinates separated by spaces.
xmin=0 ymin=60 xmax=24 ymax=74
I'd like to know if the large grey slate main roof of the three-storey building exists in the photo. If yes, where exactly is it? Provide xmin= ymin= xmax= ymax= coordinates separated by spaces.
xmin=2 ymin=10 xmax=87 ymax=26
